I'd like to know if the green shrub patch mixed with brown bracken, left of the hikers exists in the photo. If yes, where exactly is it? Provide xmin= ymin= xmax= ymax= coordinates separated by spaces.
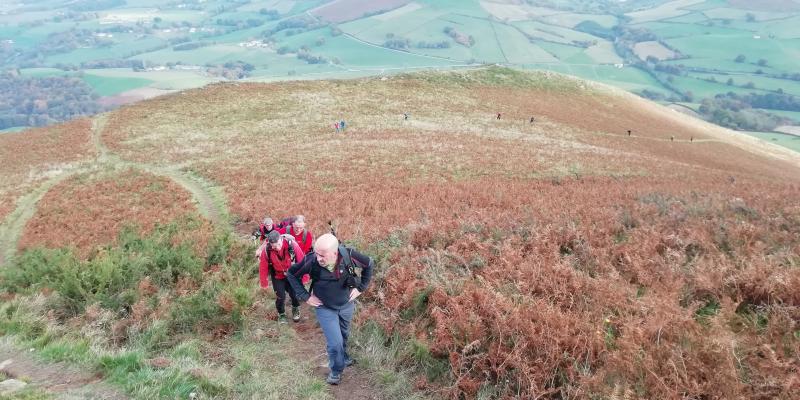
xmin=2 ymin=221 xmax=255 ymax=338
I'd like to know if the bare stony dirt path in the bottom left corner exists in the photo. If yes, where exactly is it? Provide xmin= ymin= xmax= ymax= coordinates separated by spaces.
xmin=0 ymin=343 xmax=128 ymax=400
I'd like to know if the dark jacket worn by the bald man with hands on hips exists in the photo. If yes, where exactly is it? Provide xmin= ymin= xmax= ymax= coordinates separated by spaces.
xmin=286 ymin=250 xmax=375 ymax=310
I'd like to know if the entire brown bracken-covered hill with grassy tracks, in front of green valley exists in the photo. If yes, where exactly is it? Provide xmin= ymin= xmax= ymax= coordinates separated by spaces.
xmin=0 ymin=67 xmax=800 ymax=399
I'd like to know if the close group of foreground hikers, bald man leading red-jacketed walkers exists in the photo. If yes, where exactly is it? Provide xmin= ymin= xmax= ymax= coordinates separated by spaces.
xmin=254 ymin=215 xmax=374 ymax=385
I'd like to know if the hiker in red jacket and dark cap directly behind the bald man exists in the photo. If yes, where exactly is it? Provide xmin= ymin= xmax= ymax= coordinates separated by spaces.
xmin=256 ymin=230 xmax=305 ymax=324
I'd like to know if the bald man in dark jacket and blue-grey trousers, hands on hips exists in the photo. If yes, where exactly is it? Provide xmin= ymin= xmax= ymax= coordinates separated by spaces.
xmin=286 ymin=233 xmax=374 ymax=385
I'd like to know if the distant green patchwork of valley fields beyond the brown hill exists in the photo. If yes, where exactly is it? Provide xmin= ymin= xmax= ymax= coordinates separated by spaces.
xmin=0 ymin=0 xmax=800 ymax=147
